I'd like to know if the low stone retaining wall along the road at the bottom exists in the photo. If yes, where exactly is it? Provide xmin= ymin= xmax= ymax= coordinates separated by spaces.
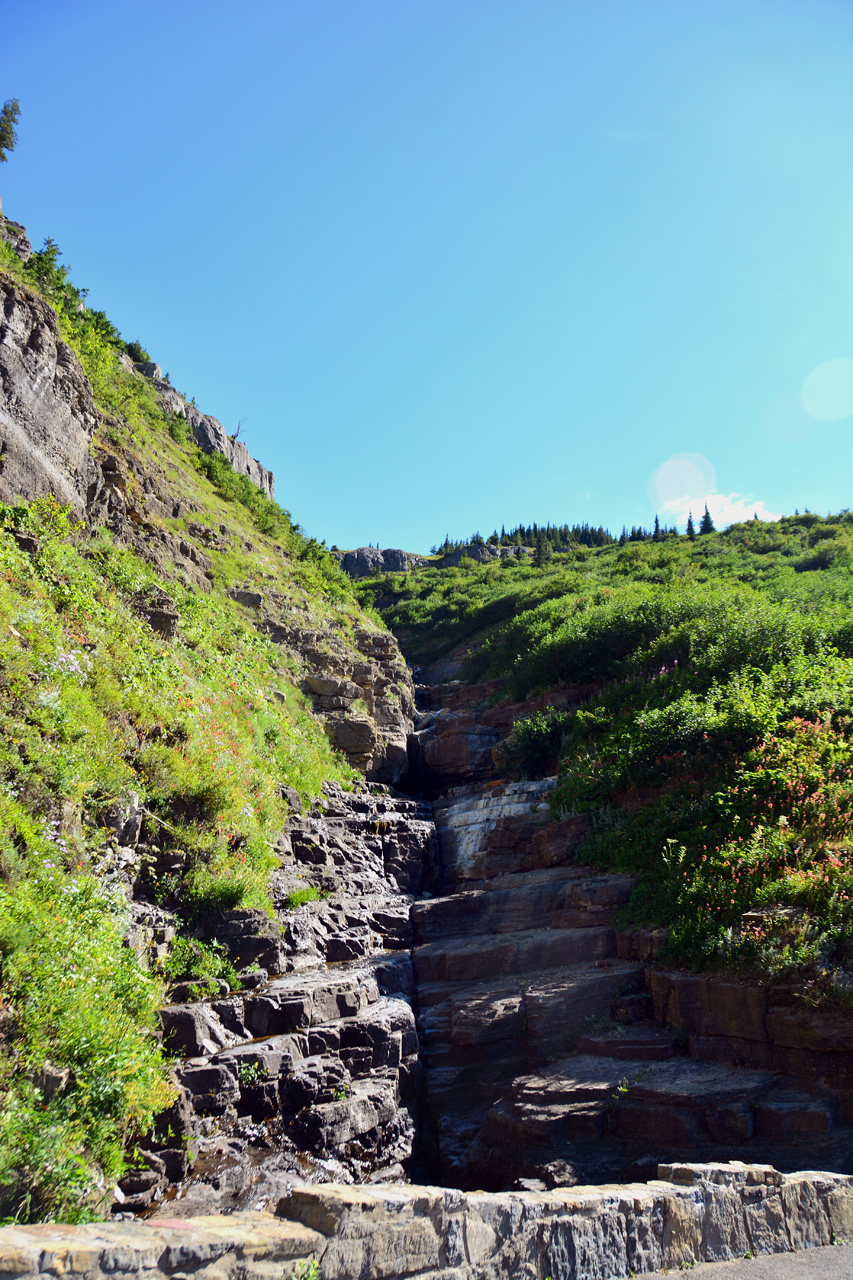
xmin=0 ymin=1162 xmax=853 ymax=1280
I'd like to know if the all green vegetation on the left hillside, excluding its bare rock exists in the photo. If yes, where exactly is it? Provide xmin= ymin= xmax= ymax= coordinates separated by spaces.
xmin=0 ymin=232 xmax=370 ymax=1220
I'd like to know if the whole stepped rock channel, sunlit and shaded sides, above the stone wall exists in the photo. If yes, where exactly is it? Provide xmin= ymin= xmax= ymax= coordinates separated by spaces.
xmin=115 ymin=660 xmax=852 ymax=1215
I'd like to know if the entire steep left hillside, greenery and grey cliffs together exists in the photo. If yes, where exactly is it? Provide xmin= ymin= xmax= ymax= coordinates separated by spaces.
xmin=0 ymin=212 xmax=412 ymax=1219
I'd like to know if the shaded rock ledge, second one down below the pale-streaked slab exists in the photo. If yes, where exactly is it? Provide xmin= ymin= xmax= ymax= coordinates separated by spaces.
xmin=412 ymin=925 xmax=616 ymax=984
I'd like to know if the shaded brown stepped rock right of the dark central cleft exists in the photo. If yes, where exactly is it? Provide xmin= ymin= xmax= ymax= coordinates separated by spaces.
xmin=402 ymin=682 xmax=853 ymax=1189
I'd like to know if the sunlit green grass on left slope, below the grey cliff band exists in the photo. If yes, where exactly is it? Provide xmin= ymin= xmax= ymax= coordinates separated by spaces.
xmin=0 ymin=500 xmax=361 ymax=1219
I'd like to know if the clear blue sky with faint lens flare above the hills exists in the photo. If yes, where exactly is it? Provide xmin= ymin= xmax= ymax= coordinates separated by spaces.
xmin=0 ymin=0 xmax=853 ymax=550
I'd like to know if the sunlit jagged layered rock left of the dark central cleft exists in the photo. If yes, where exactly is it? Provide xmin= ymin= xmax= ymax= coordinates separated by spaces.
xmin=117 ymin=786 xmax=437 ymax=1215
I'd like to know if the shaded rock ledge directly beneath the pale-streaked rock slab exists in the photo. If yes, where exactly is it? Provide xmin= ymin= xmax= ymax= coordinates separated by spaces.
xmin=411 ymin=867 xmax=633 ymax=946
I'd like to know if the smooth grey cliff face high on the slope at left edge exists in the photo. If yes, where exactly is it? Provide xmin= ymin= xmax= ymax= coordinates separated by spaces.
xmin=0 ymin=276 xmax=97 ymax=516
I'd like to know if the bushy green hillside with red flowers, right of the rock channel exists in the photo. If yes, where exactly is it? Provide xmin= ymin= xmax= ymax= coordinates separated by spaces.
xmin=360 ymin=512 xmax=853 ymax=1006
